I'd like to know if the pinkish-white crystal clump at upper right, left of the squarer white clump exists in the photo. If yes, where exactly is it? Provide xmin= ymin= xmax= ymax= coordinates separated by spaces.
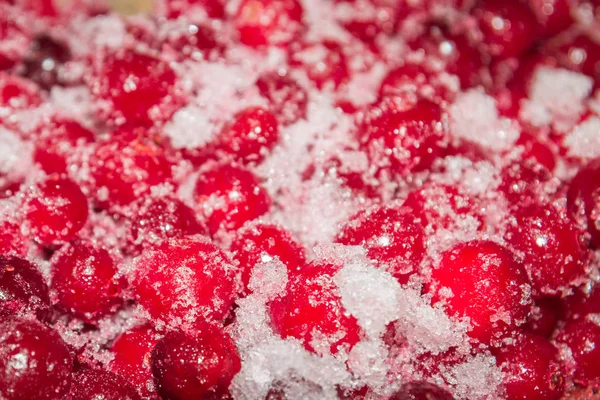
xmin=449 ymin=89 xmax=519 ymax=151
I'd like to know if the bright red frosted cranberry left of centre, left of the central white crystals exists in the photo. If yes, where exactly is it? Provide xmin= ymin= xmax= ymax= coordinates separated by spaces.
xmin=194 ymin=165 xmax=271 ymax=234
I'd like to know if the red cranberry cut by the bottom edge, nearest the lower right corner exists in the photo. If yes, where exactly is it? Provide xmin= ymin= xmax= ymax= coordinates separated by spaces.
xmin=492 ymin=333 xmax=565 ymax=400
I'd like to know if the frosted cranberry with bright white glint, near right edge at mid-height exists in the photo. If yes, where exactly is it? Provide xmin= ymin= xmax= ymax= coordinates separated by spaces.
xmin=506 ymin=205 xmax=588 ymax=294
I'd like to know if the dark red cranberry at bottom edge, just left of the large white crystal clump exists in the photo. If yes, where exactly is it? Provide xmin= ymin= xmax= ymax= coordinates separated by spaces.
xmin=152 ymin=325 xmax=241 ymax=400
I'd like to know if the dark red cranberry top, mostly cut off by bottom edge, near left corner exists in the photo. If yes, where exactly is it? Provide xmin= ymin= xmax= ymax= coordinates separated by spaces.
xmin=66 ymin=368 xmax=142 ymax=400
